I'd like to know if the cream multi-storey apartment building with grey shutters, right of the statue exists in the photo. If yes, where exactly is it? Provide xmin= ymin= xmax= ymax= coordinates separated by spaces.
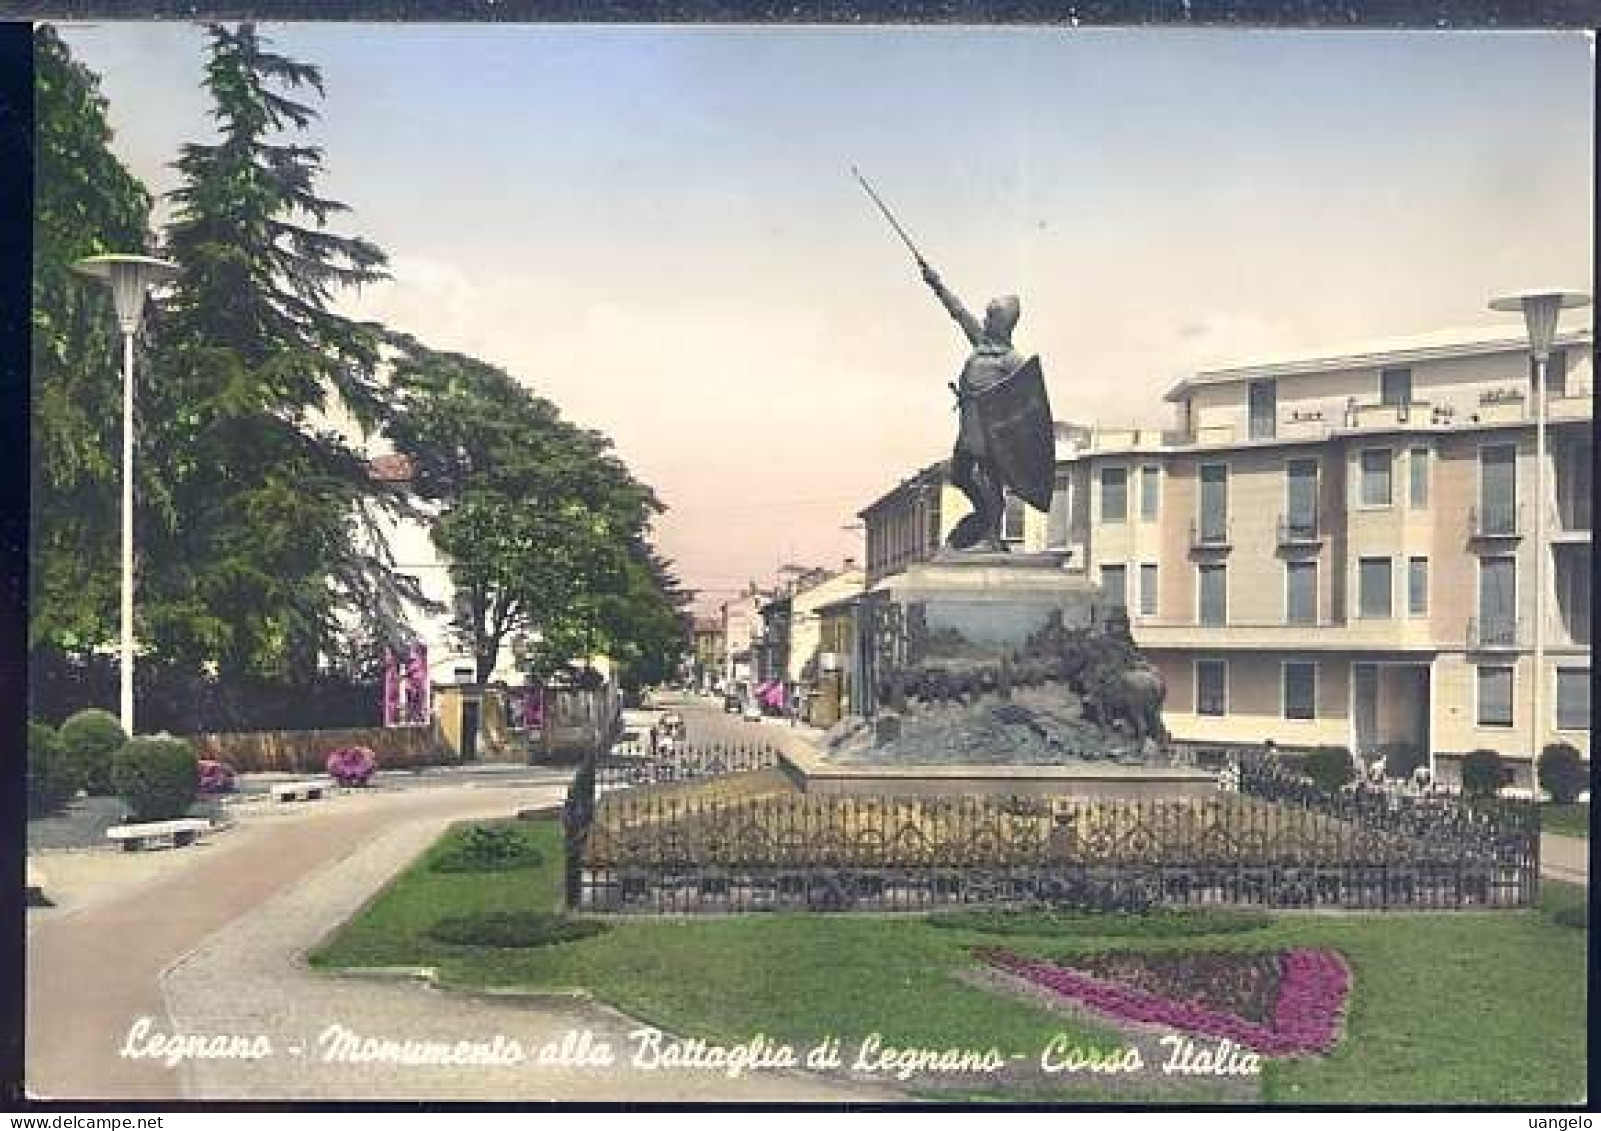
xmin=1077 ymin=332 xmax=1593 ymax=785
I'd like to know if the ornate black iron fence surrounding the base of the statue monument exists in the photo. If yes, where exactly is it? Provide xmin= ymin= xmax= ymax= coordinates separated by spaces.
xmin=565 ymin=750 xmax=1539 ymax=913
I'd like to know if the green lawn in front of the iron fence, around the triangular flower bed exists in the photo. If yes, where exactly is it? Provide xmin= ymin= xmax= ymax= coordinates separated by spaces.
xmin=312 ymin=820 xmax=1585 ymax=1104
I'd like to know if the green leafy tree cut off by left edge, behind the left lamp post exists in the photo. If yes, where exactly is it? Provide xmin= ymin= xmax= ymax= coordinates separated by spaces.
xmin=29 ymin=26 xmax=150 ymax=657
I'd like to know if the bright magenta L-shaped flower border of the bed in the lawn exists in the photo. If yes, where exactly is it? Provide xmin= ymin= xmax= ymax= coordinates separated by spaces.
xmin=973 ymin=948 xmax=1351 ymax=1056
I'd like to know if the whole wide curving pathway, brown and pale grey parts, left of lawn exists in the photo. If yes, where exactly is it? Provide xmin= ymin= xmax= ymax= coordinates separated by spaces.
xmin=27 ymin=780 xmax=884 ymax=1101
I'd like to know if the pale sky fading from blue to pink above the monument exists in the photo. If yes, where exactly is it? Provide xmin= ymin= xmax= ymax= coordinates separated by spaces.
xmin=64 ymin=22 xmax=1593 ymax=602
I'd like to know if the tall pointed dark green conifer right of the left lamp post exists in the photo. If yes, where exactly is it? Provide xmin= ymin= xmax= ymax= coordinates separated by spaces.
xmin=141 ymin=24 xmax=415 ymax=679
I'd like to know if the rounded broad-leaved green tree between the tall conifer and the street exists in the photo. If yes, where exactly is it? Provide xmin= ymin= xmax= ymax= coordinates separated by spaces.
xmin=391 ymin=336 xmax=682 ymax=681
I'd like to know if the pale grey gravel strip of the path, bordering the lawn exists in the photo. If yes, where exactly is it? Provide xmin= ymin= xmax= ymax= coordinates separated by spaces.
xmin=162 ymin=790 xmax=889 ymax=1102
